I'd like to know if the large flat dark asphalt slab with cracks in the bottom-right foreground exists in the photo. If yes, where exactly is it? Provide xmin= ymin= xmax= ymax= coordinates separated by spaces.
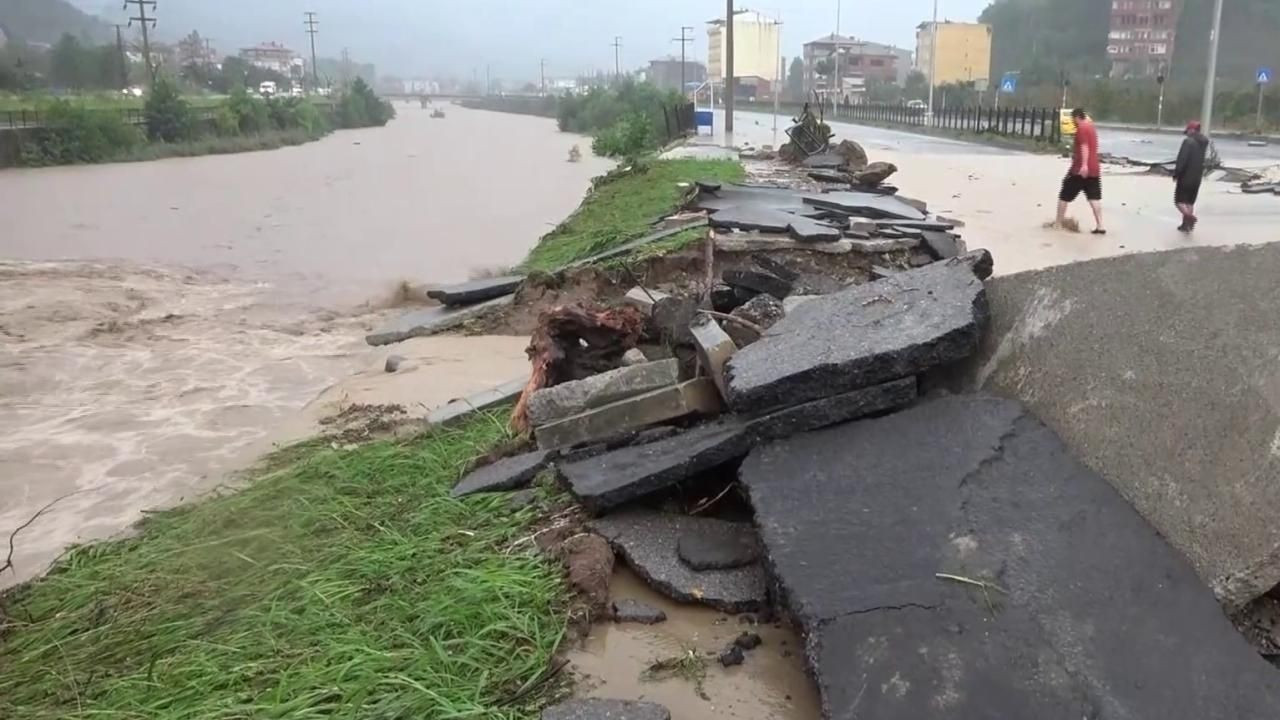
xmin=740 ymin=396 xmax=1280 ymax=720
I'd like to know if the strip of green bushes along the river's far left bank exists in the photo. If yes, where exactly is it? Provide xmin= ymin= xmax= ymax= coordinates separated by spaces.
xmin=12 ymin=76 xmax=396 ymax=167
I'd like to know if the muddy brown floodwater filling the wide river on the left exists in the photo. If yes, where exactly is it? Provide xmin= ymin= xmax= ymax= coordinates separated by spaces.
xmin=0 ymin=105 xmax=608 ymax=588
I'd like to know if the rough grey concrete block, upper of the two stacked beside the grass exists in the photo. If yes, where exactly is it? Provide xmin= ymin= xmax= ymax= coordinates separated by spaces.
xmin=529 ymin=360 xmax=680 ymax=427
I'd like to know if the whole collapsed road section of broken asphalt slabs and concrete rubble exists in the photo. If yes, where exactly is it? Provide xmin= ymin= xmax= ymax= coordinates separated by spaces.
xmin=371 ymin=131 xmax=1280 ymax=720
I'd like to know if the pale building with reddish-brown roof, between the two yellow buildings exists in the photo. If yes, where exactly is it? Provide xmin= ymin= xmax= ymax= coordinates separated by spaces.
xmin=804 ymin=35 xmax=910 ymax=99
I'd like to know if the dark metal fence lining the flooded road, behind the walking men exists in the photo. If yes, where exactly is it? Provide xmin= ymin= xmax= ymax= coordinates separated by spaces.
xmin=831 ymin=102 xmax=1062 ymax=143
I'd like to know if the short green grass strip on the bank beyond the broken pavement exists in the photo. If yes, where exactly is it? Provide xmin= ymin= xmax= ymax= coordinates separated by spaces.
xmin=522 ymin=160 xmax=744 ymax=270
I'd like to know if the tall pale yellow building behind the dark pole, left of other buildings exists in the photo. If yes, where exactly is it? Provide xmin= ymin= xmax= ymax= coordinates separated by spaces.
xmin=707 ymin=10 xmax=783 ymax=97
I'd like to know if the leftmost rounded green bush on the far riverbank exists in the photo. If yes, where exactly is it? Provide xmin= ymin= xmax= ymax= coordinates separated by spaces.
xmin=22 ymin=100 xmax=146 ymax=165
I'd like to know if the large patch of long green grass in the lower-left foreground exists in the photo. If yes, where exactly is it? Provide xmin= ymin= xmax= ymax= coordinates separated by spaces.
xmin=0 ymin=414 xmax=564 ymax=720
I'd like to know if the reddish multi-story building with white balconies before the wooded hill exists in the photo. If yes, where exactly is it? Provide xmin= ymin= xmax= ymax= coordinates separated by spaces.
xmin=1107 ymin=0 xmax=1181 ymax=77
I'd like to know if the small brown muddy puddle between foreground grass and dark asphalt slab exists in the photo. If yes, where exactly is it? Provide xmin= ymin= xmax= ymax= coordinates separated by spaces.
xmin=568 ymin=569 xmax=820 ymax=720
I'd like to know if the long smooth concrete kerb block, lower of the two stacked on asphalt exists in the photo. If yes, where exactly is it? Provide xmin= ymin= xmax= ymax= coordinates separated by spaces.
xmin=535 ymin=378 xmax=722 ymax=447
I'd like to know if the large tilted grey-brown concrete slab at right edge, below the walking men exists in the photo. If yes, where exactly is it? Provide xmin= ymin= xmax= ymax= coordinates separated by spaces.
xmin=967 ymin=245 xmax=1280 ymax=609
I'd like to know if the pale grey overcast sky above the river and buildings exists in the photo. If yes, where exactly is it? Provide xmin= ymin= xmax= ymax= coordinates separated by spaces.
xmin=73 ymin=0 xmax=991 ymax=81
